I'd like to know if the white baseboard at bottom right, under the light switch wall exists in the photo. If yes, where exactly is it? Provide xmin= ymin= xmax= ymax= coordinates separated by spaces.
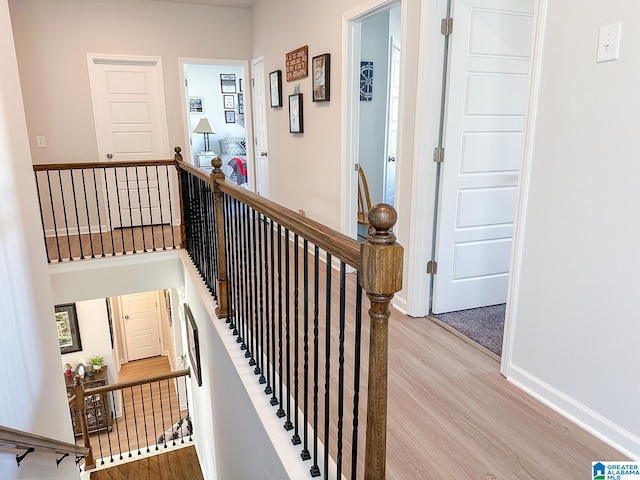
xmin=507 ymin=365 xmax=640 ymax=461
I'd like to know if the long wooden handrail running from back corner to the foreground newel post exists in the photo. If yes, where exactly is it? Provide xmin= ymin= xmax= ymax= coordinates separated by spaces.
xmin=176 ymin=158 xmax=360 ymax=270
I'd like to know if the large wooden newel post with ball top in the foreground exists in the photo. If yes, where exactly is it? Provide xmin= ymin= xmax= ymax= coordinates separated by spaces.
xmin=360 ymin=204 xmax=404 ymax=480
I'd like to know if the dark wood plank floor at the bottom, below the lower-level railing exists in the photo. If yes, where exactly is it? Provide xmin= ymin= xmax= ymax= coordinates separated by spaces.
xmin=91 ymin=446 xmax=203 ymax=480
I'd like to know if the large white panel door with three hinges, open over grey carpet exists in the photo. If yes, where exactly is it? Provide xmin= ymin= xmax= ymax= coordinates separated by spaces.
xmin=432 ymin=0 xmax=534 ymax=313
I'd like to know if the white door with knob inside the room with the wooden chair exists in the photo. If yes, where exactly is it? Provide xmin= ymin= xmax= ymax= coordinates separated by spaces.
xmin=384 ymin=37 xmax=400 ymax=206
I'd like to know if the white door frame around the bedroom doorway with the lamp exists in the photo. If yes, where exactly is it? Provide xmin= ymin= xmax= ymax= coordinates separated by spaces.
xmin=178 ymin=57 xmax=255 ymax=190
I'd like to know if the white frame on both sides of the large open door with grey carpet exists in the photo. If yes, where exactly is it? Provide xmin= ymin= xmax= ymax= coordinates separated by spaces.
xmin=405 ymin=0 xmax=548 ymax=370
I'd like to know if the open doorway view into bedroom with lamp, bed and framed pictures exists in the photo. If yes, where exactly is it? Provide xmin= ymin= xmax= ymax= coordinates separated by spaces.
xmin=180 ymin=59 xmax=255 ymax=189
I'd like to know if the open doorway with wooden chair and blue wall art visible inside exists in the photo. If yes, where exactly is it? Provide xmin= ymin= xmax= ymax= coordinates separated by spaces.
xmin=345 ymin=1 xmax=402 ymax=239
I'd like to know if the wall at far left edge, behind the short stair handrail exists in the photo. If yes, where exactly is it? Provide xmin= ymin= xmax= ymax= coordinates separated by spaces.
xmin=0 ymin=0 xmax=79 ymax=480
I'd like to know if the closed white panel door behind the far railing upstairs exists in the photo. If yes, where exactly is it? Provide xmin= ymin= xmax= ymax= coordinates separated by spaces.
xmin=88 ymin=55 xmax=171 ymax=227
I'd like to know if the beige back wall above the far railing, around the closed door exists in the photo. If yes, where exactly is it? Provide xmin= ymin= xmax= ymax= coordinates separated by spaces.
xmin=10 ymin=0 xmax=250 ymax=163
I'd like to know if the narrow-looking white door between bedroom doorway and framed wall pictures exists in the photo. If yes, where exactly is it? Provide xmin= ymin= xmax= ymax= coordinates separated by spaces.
xmin=251 ymin=58 xmax=269 ymax=198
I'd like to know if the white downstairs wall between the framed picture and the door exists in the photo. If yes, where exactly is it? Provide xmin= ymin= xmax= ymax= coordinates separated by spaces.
xmin=60 ymin=298 xmax=118 ymax=383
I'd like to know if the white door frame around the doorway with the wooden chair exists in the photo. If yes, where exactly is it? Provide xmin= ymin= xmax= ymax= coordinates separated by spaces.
xmin=340 ymin=0 xmax=408 ymax=238
